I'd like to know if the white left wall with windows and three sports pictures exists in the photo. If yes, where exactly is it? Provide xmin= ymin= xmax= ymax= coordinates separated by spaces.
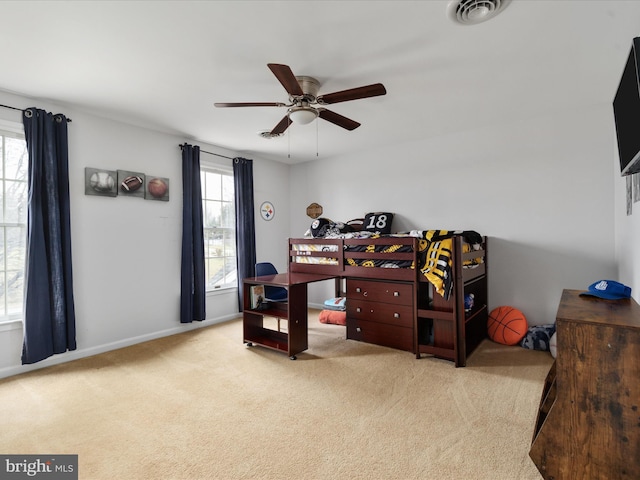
xmin=0 ymin=88 xmax=289 ymax=377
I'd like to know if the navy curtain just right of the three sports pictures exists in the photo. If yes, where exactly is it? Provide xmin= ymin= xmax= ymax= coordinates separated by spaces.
xmin=180 ymin=144 xmax=207 ymax=323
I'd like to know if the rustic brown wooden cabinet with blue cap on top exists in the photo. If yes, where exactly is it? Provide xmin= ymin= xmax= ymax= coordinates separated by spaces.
xmin=529 ymin=290 xmax=640 ymax=480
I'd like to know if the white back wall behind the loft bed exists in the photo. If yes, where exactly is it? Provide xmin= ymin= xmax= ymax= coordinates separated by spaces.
xmin=291 ymin=105 xmax=616 ymax=325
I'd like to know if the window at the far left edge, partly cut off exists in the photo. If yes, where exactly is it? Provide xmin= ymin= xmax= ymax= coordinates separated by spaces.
xmin=0 ymin=129 xmax=29 ymax=323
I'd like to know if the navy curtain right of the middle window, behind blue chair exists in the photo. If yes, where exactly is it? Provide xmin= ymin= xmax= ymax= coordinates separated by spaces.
xmin=233 ymin=157 xmax=256 ymax=311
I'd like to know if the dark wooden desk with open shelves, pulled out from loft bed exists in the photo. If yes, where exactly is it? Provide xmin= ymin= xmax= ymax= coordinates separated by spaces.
xmin=242 ymin=273 xmax=336 ymax=360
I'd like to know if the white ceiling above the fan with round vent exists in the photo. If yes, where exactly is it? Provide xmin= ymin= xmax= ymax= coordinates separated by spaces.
xmin=0 ymin=0 xmax=640 ymax=163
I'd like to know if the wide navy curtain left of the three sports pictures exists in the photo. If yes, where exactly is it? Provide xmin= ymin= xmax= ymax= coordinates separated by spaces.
xmin=22 ymin=108 xmax=76 ymax=364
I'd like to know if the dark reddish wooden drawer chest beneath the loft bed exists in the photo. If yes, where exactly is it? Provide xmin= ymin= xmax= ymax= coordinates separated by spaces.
xmin=347 ymin=278 xmax=414 ymax=352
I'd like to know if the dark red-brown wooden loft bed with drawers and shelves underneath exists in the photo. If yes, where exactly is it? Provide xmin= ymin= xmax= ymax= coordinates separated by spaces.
xmin=288 ymin=234 xmax=488 ymax=367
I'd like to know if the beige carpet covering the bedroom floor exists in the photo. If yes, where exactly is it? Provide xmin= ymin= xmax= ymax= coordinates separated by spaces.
xmin=0 ymin=311 xmax=553 ymax=480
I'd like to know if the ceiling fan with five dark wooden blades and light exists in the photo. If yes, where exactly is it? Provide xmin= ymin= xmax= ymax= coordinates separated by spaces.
xmin=214 ymin=63 xmax=387 ymax=136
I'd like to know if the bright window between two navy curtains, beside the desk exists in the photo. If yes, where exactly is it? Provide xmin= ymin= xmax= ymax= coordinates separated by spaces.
xmin=200 ymin=166 xmax=237 ymax=291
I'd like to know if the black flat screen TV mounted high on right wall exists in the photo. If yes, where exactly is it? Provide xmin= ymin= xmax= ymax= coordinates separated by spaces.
xmin=613 ymin=37 xmax=640 ymax=175
